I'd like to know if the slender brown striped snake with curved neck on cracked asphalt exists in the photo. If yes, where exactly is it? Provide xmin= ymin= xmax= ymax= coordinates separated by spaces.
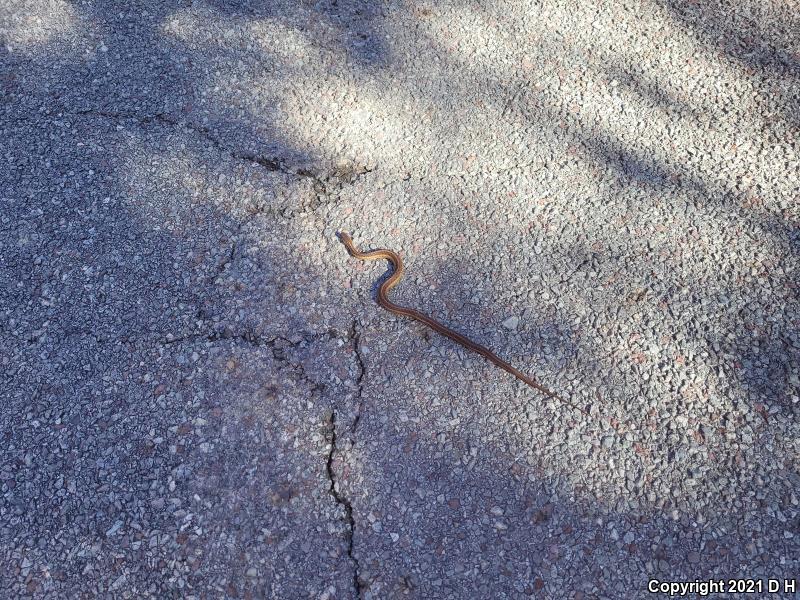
xmin=337 ymin=232 xmax=589 ymax=416
